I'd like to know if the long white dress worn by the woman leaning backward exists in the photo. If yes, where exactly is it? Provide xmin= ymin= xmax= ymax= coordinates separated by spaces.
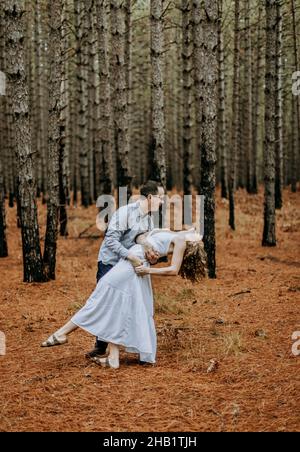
xmin=71 ymin=232 xmax=175 ymax=363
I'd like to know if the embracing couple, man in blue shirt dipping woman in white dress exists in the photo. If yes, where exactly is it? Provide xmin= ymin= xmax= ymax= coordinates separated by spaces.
xmin=42 ymin=181 xmax=206 ymax=369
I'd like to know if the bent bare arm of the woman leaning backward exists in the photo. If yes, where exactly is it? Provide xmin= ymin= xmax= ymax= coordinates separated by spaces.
xmin=135 ymin=237 xmax=186 ymax=276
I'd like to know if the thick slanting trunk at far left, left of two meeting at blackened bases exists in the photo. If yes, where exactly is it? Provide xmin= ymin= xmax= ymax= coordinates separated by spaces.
xmin=4 ymin=0 xmax=44 ymax=282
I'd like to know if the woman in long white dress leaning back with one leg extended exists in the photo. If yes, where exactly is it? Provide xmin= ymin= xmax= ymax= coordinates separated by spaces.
xmin=42 ymin=229 xmax=206 ymax=369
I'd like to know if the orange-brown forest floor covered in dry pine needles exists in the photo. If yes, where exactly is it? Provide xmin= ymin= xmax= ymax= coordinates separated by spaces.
xmin=0 ymin=185 xmax=300 ymax=432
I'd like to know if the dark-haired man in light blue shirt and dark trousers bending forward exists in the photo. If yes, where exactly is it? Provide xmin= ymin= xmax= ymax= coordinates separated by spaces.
xmin=87 ymin=181 xmax=165 ymax=358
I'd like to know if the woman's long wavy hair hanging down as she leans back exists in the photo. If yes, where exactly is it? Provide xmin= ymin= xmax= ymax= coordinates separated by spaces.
xmin=179 ymin=241 xmax=207 ymax=283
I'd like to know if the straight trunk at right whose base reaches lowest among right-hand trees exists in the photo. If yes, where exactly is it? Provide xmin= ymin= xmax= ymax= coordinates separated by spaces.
xmin=262 ymin=0 xmax=278 ymax=246
